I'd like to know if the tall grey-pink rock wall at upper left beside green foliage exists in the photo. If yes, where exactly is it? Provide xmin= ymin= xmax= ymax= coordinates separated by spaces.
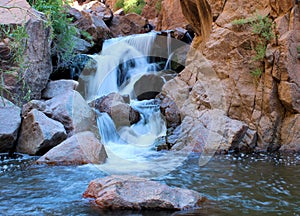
xmin=0 ymin=0 xmax=52 ymax=100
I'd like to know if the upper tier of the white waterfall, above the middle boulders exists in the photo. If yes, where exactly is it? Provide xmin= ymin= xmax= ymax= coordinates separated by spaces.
xmin=87 ymin=33 xmax=156 ymax=100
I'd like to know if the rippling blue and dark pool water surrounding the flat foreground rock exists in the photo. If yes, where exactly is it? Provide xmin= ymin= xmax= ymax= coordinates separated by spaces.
xmin=0 ymin=151 xmax=300 ymax=216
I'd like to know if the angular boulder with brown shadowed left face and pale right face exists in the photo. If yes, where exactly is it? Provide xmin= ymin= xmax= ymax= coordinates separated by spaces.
xmin=17 ymin=109 xmax=67 ymax=155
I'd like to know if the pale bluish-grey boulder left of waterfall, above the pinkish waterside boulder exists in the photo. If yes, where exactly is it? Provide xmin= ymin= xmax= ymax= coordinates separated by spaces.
xmin=45 ymin=90 xmax=96 ymax=137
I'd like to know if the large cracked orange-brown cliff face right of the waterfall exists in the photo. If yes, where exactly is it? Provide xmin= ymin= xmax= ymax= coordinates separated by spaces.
xmin=163 ymin=0 xmax=300 ymax=151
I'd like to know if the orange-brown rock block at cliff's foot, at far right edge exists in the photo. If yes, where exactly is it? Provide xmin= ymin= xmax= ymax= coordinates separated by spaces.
xmin=280 ymin=114 xmax=300 ymax=152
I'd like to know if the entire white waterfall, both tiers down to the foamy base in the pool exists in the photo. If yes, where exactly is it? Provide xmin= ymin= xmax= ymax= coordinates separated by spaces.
xmin=83 ymin=33 xmax=190 ymax=176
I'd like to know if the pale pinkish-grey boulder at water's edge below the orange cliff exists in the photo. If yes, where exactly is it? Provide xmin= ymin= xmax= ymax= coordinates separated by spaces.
xmin=172 ymin=109 xmax=257 ymax=155
